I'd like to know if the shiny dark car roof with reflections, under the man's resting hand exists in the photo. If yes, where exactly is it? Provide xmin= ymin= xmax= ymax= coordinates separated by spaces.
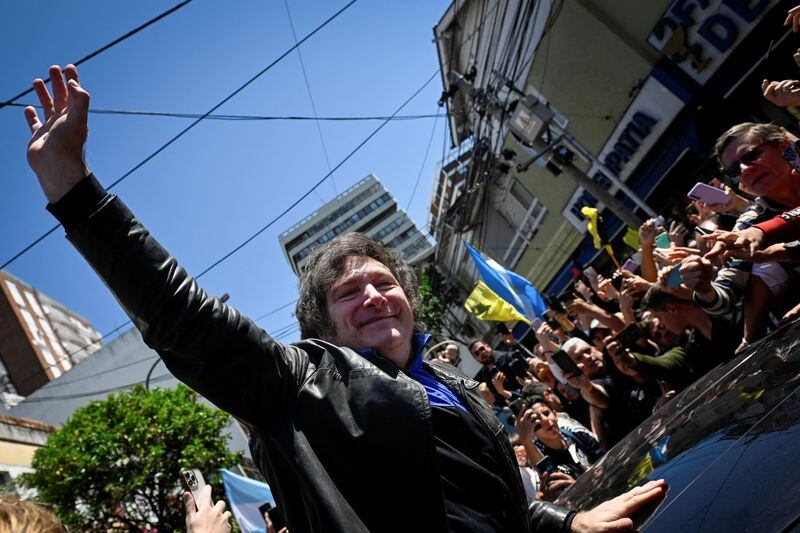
xmin=558 ymin=322 xmax=800 ymax=533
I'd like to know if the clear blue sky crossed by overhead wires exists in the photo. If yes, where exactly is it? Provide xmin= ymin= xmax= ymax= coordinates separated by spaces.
xmin=0 ymin=0 xmax=449 ymax=341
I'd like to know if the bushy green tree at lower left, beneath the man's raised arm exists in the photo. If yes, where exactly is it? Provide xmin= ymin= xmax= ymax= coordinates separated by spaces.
xmin=23 ymin=385 xmax=241 ymax=531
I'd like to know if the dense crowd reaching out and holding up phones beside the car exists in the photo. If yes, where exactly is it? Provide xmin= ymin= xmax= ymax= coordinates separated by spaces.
xmin=424 ymin=20 xmax=800 ymax=501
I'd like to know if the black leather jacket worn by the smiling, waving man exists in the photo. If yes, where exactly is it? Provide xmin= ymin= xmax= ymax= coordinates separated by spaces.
xmin=50 ymin=177 xmax=568 ymax=533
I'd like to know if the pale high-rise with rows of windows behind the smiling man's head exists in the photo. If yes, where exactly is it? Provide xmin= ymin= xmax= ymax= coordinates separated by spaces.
xmin=278 ymin=174 xmax=433 ymax=275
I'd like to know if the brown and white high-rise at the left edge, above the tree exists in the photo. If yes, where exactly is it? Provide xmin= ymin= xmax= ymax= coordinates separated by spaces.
xmin=0 ymin=270 xmax=102 ymax=396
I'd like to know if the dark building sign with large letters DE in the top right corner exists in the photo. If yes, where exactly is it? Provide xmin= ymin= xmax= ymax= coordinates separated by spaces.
xmin=647 ymin=0 xmax=780 ymax=85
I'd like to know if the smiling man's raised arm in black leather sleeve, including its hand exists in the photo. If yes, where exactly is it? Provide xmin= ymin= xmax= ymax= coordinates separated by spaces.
xmin=25 ymin=66 xmax=309 ymax=426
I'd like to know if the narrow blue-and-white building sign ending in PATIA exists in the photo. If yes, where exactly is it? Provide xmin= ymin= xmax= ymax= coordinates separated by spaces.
xmin=562 ymin=77 xmax=683 ymax=233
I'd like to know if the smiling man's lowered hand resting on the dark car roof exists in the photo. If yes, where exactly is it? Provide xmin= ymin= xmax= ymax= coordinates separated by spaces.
xmin=572 ymin=479 xmax=668 ymax=533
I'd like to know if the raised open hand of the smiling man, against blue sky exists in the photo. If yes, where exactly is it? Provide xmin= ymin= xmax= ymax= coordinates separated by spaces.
xmin=25 ymin=65 xmax=89 ymax=202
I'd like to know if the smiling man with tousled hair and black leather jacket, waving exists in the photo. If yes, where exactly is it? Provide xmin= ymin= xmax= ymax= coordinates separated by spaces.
xmin=25 ymin=65 xmax=665 ymax=533
